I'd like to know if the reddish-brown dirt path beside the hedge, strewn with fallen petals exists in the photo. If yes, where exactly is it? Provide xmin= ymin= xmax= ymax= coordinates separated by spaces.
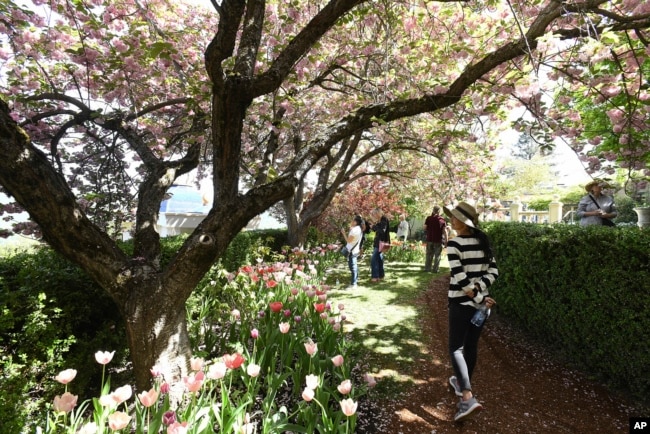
xmin=364 ymin=277 xmax=650 ymax=434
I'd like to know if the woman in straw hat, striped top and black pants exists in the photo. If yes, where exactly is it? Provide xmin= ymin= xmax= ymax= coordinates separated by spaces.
xmin=443 ymin=202 xmax=499 ymax=421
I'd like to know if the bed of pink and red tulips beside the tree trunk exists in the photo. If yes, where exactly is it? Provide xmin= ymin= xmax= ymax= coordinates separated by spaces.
xmin=44 ymin=246 xmax=375 ymax=434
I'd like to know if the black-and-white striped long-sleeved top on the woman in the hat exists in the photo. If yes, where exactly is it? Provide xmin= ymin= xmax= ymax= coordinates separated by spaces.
xmin=447 ymin=235 xmax=499 ymax=308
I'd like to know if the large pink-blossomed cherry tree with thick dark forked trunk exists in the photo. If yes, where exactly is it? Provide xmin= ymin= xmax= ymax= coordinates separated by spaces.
xmin=0 ymin=0 xmax=650 ymax=388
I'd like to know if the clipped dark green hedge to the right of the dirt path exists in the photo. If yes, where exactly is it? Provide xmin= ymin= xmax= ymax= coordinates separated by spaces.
xmin=486 ymin=223 xmax=650 ymax=400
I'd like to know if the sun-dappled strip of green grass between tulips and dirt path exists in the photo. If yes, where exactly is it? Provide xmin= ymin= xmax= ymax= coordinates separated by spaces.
xmin=327 ymin=255 xmax=449 ymax=397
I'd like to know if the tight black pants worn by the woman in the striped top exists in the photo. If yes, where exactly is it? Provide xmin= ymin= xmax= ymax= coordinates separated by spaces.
xmin=449 ymin=303 xmax=483 ymax=390
